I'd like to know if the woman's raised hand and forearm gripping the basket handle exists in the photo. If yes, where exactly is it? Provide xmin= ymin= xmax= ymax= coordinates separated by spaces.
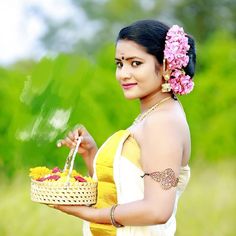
xmin=57 ymin=125 xmax=98 ymax=176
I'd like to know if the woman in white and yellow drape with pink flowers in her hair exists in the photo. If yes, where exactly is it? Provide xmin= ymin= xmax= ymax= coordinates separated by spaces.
xmin=55 ymin=20 xmax=196 ymax=236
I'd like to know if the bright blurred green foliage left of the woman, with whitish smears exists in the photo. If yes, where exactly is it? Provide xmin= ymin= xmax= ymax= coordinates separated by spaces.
xmin=0 ymin=45 xmax=138 ymax=176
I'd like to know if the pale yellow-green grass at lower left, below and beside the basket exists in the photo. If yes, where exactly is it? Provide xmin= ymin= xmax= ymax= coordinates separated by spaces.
xmin=0 ymin=176 xmax=82 ymax=236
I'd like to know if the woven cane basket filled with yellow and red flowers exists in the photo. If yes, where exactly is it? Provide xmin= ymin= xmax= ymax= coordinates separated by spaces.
xmin=29 ymin=166 xmax=97 ymax=205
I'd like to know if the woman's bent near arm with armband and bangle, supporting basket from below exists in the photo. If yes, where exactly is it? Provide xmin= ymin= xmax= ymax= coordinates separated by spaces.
xmin=56 ymin=113 xmax=184 ymax=225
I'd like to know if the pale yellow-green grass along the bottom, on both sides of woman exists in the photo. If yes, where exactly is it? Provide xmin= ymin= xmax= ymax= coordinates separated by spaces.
xmin=0 ymin=160 xmax=236 ymax=236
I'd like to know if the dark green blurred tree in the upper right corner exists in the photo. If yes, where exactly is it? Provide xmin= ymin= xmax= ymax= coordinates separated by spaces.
xmin=174 ymin=0 xmax=236 ymax=41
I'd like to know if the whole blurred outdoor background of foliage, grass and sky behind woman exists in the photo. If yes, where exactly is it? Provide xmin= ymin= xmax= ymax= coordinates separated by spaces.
xmin=0 ymin=0 xmax=236 ymax=236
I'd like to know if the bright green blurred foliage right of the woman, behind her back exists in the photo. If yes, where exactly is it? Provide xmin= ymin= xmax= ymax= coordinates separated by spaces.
xmin=183 ymin=32 xmax=236 ymax=160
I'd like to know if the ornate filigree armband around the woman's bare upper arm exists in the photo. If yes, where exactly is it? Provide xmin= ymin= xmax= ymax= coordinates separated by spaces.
xmin=141 ymin=168 xmax=179 ymax=190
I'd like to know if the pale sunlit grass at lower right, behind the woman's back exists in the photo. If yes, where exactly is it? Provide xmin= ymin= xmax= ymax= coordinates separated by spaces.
xmin=176 ymin=159 xmax=236 ymax=236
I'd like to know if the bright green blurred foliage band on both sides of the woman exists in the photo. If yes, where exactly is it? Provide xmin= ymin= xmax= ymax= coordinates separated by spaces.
xmin=0 ymin=32 xmax=236 ymax=179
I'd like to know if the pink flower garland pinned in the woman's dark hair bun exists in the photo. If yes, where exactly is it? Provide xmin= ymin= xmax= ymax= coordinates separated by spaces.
xmin=162 ymin=25 xmax=194 ymax=95
